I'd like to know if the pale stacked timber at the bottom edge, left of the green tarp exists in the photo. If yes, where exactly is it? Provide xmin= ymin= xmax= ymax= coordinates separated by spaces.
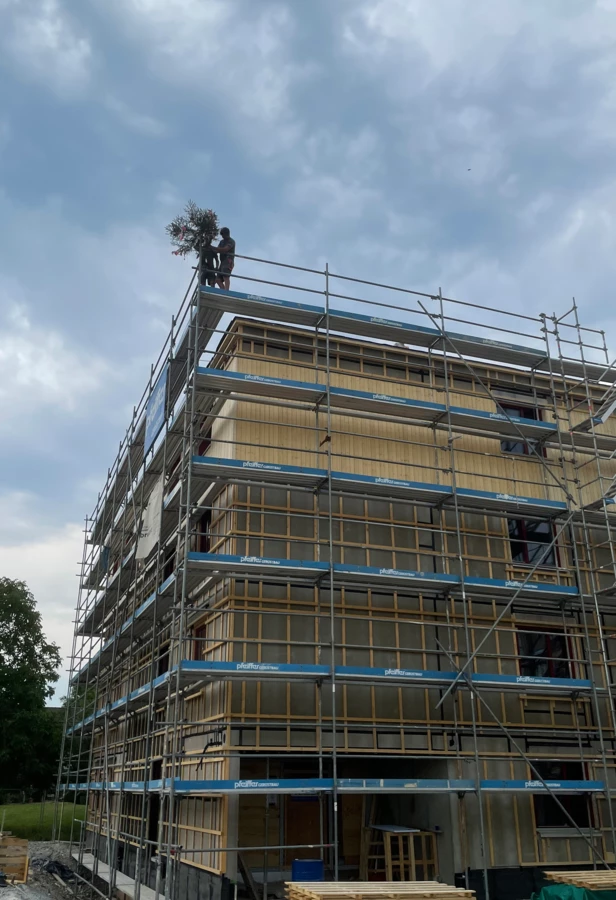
xmin=285 ymin=881 xmax=475 ymax=900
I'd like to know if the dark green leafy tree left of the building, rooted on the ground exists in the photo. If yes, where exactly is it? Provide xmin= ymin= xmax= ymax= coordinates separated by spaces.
xmin=0 ymin=578 xmax=62 ymax=791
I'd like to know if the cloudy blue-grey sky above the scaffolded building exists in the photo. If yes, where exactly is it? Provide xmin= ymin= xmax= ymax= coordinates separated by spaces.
xmin=0 ymin=0 xmax=616 ymax=704
